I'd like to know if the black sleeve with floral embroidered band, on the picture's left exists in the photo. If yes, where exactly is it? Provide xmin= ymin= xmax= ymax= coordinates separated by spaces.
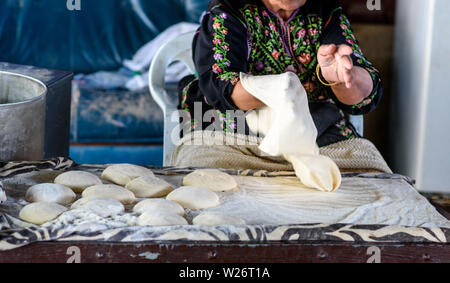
xmin=193 ymin=5 xmax=248 ymax=112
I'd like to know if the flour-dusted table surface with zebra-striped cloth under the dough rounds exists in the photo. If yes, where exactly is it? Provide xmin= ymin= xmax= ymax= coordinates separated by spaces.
xmin=0 ymin=159 xmax=450 ymax=261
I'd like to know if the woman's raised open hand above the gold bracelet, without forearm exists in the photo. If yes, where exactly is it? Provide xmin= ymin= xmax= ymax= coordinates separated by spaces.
xmin=317 ymin=44 xmax=353 ymax=88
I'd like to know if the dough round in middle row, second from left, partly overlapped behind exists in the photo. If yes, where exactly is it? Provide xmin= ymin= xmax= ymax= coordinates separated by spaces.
xmin=82 ymin=185 xmax=136 ymax=204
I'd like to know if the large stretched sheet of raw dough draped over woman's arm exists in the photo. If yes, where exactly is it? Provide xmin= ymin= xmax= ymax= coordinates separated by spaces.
xmin=241 ymin=72 xmax=341 ymax=192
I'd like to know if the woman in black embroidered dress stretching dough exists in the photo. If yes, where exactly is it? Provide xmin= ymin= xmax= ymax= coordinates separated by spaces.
xmin=180 ymin=0 xmax=382 ymax=149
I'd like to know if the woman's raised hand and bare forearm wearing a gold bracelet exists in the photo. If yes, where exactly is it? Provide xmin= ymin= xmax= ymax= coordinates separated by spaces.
xmin=317 ymin=44 xmax=373 ymax=105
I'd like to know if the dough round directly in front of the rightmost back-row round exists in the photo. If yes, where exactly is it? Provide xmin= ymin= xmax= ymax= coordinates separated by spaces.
xmin=166 ymin=187 xmax=220 ymax=210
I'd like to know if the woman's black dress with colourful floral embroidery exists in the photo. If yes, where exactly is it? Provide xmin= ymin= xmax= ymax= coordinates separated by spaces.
xmin=180 ymin=0 xmax=382 ymax=145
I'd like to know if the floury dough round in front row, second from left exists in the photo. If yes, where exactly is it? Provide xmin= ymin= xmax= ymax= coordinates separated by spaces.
xmin=71 ymin=197 xmax=125 ymax=217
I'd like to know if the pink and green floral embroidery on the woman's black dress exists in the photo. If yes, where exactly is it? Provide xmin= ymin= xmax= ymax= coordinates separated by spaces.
xmin=182 ymin=4 xmax=381 ymax=138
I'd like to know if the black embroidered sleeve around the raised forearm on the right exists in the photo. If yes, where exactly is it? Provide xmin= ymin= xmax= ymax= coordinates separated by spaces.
xmin=322 ymin=1 xmax=383 ymax=115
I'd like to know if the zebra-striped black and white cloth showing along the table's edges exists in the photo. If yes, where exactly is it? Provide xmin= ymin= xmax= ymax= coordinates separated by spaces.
xmin=0 ymin=158 xmax=450 ymax=251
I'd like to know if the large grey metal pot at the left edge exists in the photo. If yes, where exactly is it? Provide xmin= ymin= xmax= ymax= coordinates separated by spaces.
xmin=0 ymin=71 xmax=47 ymax=161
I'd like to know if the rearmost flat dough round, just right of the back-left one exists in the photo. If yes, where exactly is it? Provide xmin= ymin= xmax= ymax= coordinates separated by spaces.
xmin=102 ymin=164 xmax=154 ymax=186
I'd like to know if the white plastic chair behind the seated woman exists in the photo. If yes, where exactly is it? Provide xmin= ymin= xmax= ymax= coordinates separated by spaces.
xmin=149 ymin=32 xmax=364 ymax=166
